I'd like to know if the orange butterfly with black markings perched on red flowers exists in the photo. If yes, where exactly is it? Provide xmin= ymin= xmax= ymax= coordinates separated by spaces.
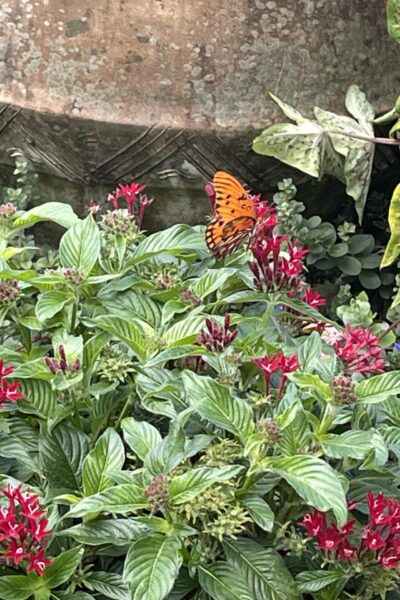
xmin=206 ymin=171 xmax=256 ymax=258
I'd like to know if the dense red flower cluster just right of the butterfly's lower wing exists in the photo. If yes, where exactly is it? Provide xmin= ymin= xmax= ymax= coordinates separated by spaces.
xmin=249 ymin=233 xmax=308 ymax=293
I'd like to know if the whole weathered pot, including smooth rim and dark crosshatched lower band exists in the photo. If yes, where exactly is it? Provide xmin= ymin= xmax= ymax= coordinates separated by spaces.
xmin=0 ymin=0 xmax=400 ymax=225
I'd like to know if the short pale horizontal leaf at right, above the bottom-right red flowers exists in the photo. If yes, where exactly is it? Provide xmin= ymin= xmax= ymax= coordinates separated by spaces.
xmin=319 ymin=430 xmax=373 ymax=460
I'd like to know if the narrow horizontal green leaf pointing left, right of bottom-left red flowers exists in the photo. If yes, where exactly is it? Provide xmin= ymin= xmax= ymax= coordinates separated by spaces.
xmin=59 ymin=519 xmax=146 ymax=546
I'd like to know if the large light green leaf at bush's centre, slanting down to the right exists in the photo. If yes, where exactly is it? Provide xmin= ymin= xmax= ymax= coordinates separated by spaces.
xmin=182 ymin=371 xmax=254 ymax=439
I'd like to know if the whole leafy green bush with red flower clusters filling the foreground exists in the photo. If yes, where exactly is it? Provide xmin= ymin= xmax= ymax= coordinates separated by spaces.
xmin=0 ymin=173 xmax=400 ymax=600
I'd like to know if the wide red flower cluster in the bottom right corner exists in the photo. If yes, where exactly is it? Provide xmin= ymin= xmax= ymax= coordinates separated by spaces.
xmin=300 ymin=492 xmax=400 ymax=569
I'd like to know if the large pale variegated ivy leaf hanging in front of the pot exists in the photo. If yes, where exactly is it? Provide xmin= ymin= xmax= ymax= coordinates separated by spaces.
xmin=253 ymin=85 xmax=375 ymax=221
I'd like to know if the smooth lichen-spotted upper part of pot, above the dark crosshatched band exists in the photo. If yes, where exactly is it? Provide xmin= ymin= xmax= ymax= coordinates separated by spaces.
xmin=0 ymin=0 xmax=400 ymax=129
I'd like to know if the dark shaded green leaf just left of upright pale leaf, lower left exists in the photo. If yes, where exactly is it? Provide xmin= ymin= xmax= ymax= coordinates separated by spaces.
xmin=39 ymin=423 xmax=89 ymax=491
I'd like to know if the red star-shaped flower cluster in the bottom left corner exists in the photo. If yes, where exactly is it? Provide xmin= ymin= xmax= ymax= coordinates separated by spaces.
xmin=0 ymin=485 xmax=51 ymax=575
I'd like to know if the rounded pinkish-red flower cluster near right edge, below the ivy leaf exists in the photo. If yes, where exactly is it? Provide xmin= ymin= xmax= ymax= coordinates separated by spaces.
xmin=333 ymin=325 xmax=385 ymax=373
